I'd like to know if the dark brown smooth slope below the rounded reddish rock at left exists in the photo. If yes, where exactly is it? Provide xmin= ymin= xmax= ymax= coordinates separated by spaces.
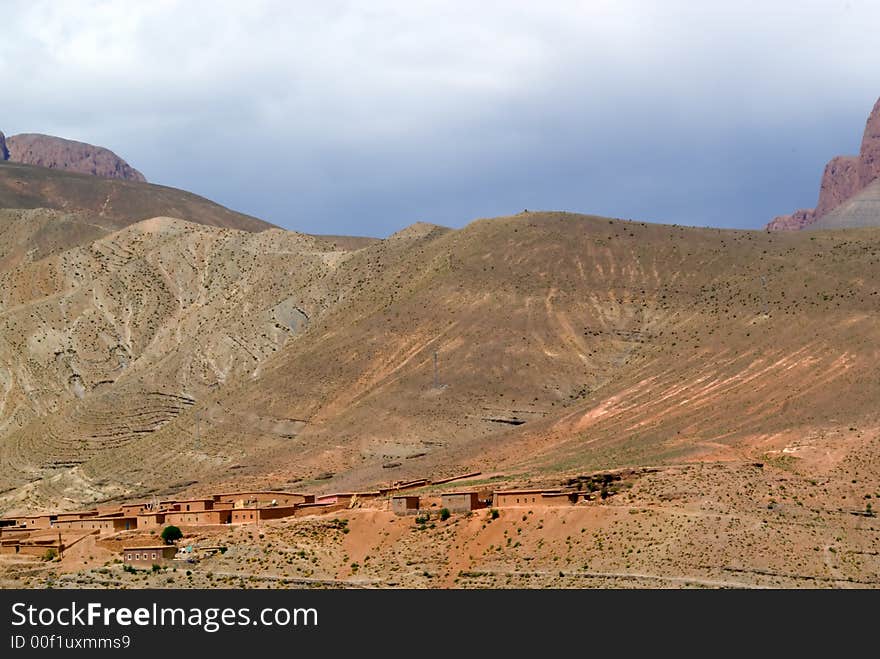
xmin=0 ymin=161 xmax=273 ymax=231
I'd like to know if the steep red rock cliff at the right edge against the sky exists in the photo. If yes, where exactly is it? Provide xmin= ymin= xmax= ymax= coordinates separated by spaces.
xmin=767 ymin=100 xmax=880 ymax=231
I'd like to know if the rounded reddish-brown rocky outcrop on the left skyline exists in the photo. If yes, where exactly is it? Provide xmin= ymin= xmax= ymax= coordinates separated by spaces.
xmin=6 ymin=134 xmax=146 ymax=182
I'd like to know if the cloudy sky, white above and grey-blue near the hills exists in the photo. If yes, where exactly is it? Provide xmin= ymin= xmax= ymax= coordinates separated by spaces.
xmin=0 ymin=0 xmax=880 ymax=237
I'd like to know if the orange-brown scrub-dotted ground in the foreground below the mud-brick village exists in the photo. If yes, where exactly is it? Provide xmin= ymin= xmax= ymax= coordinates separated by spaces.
xmin=0 ymin=455 xmax=880 ymax=588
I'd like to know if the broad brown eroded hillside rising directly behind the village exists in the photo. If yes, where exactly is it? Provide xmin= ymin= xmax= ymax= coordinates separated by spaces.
xmin=0 ymin=211 xmax=880 ymax=509
